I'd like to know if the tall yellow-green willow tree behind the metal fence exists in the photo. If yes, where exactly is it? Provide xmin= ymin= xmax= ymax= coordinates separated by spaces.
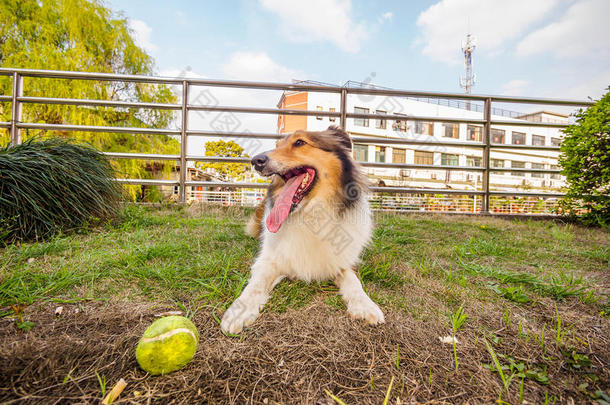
xmin=0 ymin=0 xmax=179 ymax=197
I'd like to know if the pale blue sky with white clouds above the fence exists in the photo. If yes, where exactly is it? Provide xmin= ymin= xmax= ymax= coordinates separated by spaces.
xmin=106 ymin=0 xmax=610 ymax=99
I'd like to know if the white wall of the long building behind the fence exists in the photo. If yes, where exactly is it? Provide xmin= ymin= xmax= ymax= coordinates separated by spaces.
xmin=307 ymin=92 xmax=564 ymax=190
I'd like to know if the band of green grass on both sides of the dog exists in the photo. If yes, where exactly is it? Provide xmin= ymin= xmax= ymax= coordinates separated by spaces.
xmin=0 ymin=205 xmax=609 ymax=319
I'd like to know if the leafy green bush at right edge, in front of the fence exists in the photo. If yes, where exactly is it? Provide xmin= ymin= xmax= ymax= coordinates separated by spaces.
xmin=559 ymin=88 xmax=610 ymax=226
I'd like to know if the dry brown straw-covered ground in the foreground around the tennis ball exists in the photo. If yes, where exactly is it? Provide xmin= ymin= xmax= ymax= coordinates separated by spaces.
xmin=0 ymin=300 xmax=610 ymax=405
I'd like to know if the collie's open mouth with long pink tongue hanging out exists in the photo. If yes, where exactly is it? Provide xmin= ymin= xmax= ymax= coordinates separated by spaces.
xmin=266 ymin=167 xmax=316 ymax=233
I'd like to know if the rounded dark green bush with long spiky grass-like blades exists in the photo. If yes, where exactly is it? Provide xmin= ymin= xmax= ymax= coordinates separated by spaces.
xmin=0 ymin=138 xmax=121 ymax=243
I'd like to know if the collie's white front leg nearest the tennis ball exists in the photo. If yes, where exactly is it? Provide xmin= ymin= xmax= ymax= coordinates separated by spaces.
xmin=220 ymin=260 xmax=284 ymax=333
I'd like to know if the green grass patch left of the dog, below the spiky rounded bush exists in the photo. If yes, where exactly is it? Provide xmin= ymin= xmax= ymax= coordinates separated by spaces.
xmin=0 ymin=208 xmax=256 ymax=305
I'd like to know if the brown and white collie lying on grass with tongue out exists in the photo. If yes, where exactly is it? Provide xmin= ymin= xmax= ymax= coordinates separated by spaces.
xmin=220 ymin=126 xmax=384 ymax=334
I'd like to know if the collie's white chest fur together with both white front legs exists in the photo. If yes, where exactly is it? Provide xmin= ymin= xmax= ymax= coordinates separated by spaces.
xmin=220 ymin=196 xmax=384 ymax=333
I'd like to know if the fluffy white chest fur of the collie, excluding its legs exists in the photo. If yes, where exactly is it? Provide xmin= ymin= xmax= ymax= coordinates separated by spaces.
xmin=259 ymin=198 xmax=372 ymax=281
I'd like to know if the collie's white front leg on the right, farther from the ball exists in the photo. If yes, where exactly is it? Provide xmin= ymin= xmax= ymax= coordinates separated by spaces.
xmin=335 ymin=269 xmax=385 ymax=325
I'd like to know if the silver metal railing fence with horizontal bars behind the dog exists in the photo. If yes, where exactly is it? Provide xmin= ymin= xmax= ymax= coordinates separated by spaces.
xmin=0 ymin=68 xmax=593 ymax=214
